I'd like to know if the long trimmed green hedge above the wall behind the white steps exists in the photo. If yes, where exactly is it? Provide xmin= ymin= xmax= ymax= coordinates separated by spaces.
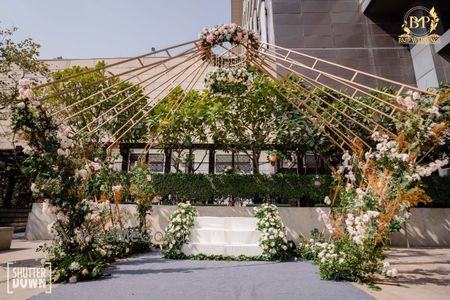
xmin=153 ymin=173 xmax=332 ymax=203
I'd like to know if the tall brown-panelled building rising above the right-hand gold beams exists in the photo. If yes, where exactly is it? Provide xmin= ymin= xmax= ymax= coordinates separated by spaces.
xmin=236 ymin=0 xmax=450 ymax=88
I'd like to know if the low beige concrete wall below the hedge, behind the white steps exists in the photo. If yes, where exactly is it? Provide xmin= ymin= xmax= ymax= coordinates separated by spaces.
xmin=26 ymin=203 xmax=450 ymax=247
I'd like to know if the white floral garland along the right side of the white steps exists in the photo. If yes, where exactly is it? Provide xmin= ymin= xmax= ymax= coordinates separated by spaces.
xmin=254 ymin=204 xmax=288 ymax=260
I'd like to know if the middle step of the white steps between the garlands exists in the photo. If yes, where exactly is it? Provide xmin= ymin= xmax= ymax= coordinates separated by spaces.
xmin=190 ymin=229 xmax=261 ymax=244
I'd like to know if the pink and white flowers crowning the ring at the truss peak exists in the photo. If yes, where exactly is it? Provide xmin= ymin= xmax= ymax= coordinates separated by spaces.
xmin=199 ymin=23 xmax=261 ymax=60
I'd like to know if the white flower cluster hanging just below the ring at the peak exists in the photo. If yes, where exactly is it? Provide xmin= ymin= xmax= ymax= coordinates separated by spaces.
xmin=205 ymin=68 xmax=255 ymax=94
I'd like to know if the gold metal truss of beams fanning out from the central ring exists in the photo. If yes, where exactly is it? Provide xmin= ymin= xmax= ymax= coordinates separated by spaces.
xmin=34 ymin=27 xmax=438 ymax=162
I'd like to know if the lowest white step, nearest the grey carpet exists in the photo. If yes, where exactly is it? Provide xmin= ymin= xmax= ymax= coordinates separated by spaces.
xmin=181 ymin=243 xmax=262 ymax=256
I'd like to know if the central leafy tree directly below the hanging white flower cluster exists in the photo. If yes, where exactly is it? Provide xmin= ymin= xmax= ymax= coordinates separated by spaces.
xmin=210 ymin=69 xmax=284 ymax=173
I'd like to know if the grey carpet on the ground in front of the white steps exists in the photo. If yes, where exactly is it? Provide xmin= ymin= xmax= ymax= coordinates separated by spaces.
xmin=32 ymin=253 xmax=372 ymax=300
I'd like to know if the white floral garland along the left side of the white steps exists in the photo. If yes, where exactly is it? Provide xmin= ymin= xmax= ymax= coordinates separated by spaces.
xmin=162 ymin=202 xmax=197 ymax=258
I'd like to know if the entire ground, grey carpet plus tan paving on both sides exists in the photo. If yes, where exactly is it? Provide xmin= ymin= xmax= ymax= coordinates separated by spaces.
xmin=0 ymin=235 xmax=450 ymax=300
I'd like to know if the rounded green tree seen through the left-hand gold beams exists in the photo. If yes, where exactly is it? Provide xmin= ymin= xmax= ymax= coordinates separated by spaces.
xmin=49 ymin=61 xmax=147 ymax=143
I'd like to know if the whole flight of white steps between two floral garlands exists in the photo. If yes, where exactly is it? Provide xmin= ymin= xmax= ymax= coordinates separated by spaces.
xmin=181 ymin=217 xmax=262 ymax=256
